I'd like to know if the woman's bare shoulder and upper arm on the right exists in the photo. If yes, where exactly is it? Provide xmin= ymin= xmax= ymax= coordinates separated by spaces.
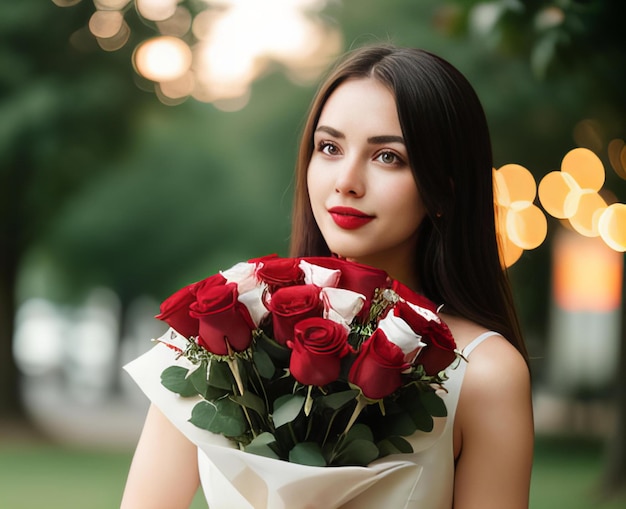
xmin=454 ymin=336 xmax=534 ymax=509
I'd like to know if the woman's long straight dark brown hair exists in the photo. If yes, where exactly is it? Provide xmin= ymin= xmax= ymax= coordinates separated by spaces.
xmin=291 ymin=45 xmax=528 ymax=359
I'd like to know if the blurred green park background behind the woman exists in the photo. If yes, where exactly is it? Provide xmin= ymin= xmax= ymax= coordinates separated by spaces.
xmin=0 ymin=0 xmax=626 ymax=509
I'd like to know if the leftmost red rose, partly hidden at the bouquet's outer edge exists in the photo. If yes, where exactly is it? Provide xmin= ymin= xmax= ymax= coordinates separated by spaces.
xmin=155 ymin=274 xmax=226 ymax=338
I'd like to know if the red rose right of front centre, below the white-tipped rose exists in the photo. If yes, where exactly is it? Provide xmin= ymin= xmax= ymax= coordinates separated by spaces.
xmin=348 ymin=329 xmax=409 ymax=399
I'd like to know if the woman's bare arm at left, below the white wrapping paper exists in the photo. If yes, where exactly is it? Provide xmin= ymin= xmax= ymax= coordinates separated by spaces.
xmin=121 ymin=405 xmax=200 ymax=509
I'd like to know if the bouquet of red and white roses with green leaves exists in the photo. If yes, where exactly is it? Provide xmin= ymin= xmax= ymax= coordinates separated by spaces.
xmin=157 ymin=255 xmax=458 ymax=466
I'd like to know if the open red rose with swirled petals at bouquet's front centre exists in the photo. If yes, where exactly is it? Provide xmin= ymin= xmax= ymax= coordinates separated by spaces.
xmin=287 ymin=317 xmax=352 ymax=386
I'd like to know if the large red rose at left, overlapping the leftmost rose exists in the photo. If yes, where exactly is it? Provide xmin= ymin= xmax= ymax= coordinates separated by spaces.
xmin=190 ymin=283 xmax=255 ymax=355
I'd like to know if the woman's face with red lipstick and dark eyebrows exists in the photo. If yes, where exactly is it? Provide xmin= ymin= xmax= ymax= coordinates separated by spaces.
xmin=307 ymin=78 xmax=426 ymax=278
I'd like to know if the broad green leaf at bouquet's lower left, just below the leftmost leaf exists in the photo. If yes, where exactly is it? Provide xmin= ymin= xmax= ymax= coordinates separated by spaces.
xmin=189 ymin=398 xmax=248 ymax=437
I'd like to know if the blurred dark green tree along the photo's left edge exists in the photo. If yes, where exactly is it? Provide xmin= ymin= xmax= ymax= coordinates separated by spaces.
xmin=0 ymin=0 xmax=150 ymax=416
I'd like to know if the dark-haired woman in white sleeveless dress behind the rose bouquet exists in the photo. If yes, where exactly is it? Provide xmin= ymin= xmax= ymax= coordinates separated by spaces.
xmin=122 ymin=46 xmax=533 ymax=509
